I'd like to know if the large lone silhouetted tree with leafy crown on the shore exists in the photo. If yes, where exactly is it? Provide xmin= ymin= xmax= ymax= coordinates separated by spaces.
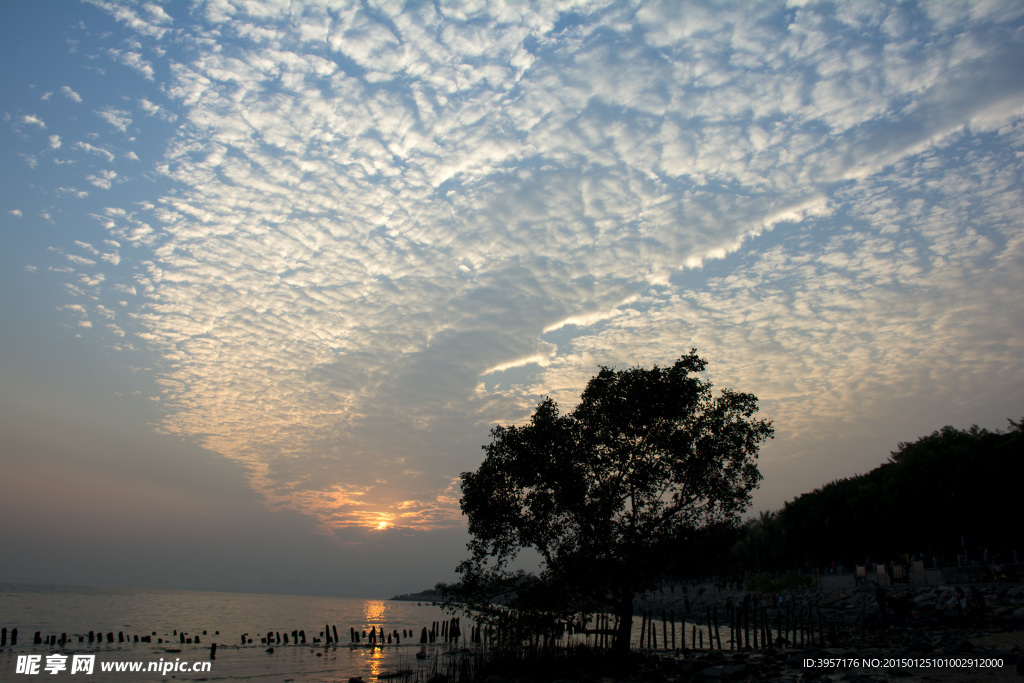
xmin=458 ymin=350 xmax=773 ymax=649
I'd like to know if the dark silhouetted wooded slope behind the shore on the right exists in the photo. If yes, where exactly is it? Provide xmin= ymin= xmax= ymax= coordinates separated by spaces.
xmin=731 ymin=420 xmax=1024 ymax=571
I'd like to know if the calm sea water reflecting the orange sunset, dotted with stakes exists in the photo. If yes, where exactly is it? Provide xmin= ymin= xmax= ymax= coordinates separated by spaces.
xmin=0 ymin=584 xmax=469 ymax=683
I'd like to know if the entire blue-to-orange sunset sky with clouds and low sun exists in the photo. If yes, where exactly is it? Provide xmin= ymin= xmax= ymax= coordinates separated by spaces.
xmin=0 ymin=0 xmax=1024 ymax=595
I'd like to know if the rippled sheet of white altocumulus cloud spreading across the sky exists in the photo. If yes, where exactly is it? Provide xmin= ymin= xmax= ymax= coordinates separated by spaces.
xmin=37 ymin=0 xmax=1024 ymax=528
